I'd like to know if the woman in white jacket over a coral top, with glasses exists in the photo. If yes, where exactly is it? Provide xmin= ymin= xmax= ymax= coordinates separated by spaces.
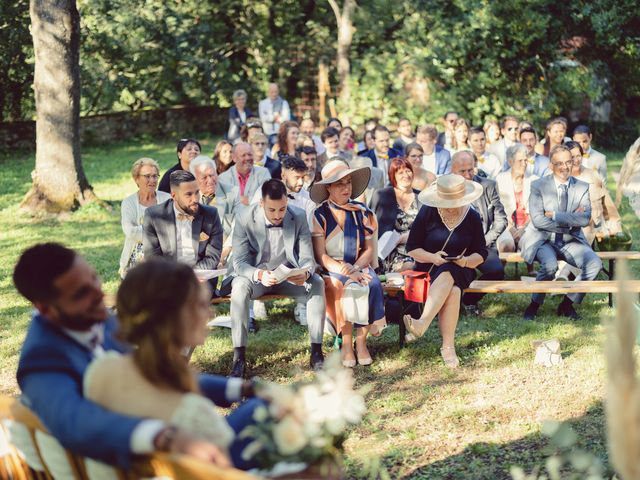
xmin=496 ymin=143 xmax=538 ymax=268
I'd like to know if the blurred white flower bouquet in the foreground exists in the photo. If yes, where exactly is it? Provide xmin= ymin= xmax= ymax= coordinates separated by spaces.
xmin=240 ymin=354 xmax=366 ymax=470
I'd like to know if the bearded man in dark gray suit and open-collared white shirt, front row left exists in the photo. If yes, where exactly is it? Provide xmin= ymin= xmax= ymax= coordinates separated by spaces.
xmin=142 ymin=170 xmax=222 ymax=270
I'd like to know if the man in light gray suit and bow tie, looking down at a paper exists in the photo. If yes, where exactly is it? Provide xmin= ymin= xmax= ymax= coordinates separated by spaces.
xmin=230 ymin=179 xmax=325 ymax=377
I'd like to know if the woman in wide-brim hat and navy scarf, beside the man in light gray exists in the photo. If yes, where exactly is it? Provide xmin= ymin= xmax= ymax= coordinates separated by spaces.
xmin=310 ymin=160 xmax=386 ymax=367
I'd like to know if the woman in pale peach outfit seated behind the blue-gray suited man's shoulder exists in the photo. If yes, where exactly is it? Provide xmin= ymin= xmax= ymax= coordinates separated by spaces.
xmin=565 ymin=140 xmax=622 ymax=245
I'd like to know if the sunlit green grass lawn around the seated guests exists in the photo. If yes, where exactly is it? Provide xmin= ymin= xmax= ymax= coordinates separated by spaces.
xmin=0 ymin=139 xmax=640 ymax=479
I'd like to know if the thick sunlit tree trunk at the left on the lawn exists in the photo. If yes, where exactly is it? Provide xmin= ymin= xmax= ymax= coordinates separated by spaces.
xmin=22 ymin=0 xmax=95 ymax=213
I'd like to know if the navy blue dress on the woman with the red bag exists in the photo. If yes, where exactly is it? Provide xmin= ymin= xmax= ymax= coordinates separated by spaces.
xmin=406 ymin=205 xmax=488 ymax=290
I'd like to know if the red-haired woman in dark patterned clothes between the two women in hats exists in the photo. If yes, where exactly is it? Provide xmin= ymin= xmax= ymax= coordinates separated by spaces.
xmin=371 ymin=157 xmax=420 ymax=272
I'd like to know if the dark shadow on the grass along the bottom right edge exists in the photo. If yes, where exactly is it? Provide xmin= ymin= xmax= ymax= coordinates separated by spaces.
xmin=370 ymin=402 xmax=614 ymax=480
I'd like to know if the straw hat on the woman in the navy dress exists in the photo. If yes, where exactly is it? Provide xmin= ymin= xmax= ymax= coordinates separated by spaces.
xmin=418 ymin=174 xmax=483 ymax=208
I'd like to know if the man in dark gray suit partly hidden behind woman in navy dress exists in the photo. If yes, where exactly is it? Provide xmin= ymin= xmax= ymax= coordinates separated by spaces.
xmin=451 ymin=150 xmax=507 ymax=315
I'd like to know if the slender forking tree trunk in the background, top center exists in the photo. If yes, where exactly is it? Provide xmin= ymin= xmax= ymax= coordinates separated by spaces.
xmin=329 ymin=0 xmax=356 ymax=123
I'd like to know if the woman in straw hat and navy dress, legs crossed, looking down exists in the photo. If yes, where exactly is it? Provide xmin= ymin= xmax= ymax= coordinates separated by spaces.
xmin=404 ymin=175 xmax=487 ymax=368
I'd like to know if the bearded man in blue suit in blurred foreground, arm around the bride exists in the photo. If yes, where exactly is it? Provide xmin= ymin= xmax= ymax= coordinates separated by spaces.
xmin=13 ymin=243 xmax=259 ymax=468
